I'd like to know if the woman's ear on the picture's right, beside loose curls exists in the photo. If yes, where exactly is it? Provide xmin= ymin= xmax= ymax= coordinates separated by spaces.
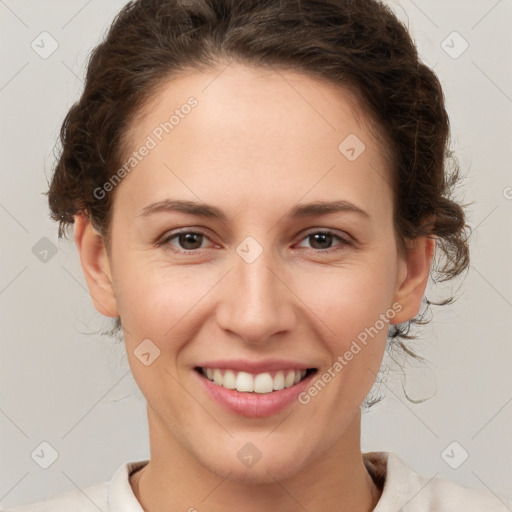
xmin=390 ymin=237 xmax=436 ymax=324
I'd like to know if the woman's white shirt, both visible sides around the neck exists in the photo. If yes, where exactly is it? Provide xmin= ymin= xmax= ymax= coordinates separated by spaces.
xmin=4 ymin=452 xmax=512 ymax=512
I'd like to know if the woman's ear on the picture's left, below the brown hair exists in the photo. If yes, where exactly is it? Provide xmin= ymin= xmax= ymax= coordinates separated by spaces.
xmin=74 ymin=212 xmax=119 ymax=317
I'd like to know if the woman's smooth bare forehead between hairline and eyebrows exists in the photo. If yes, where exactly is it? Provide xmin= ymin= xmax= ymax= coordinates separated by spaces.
xmin=116 ymin=63 xmax=390 ymax=223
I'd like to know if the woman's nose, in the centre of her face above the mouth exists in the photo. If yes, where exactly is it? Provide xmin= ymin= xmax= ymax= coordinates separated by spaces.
xmin=217 ymin=243 xmax=296 ymax=345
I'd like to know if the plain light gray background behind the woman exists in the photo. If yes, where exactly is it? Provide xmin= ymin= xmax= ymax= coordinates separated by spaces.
xmin=0 ymin=0 xmax=512 ymax=510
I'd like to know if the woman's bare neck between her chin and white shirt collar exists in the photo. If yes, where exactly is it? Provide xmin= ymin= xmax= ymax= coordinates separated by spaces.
xmin=130 ymin=406 xmax=382 ymax=512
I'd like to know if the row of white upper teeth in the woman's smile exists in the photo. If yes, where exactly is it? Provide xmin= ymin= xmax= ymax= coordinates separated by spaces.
xmin=201 ymin=368 xmax=306 ymax=393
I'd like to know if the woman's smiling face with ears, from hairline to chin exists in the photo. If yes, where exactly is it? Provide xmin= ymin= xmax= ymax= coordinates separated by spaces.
xmin=78 ymin=64 xmax=431 ymax=481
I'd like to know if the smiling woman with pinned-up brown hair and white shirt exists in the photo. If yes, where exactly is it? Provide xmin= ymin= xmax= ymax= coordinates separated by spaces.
xmin=6 ymin=0 xmax=512 ymax=512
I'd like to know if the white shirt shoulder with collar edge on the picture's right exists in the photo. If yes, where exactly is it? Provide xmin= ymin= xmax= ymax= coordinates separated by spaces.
xmin=364 ymin=452 xmax=512 ymax=512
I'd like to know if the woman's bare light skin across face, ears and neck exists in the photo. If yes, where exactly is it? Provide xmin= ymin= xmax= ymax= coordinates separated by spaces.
xmin=75 ymin=64 xmax=435 ymax=512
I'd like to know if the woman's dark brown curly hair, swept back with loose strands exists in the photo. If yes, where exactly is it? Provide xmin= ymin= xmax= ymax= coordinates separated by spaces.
xmin=47 ymin=0 xmax=470 ymax=388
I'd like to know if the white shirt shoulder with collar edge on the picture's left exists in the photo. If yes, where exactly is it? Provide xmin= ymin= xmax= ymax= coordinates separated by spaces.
xmin=0 ymin=459 xmax=148 ymax=512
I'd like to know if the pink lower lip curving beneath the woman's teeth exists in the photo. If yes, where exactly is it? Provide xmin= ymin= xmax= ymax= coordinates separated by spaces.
xmin=193 ymin=370 xmax=316 ymax=418
